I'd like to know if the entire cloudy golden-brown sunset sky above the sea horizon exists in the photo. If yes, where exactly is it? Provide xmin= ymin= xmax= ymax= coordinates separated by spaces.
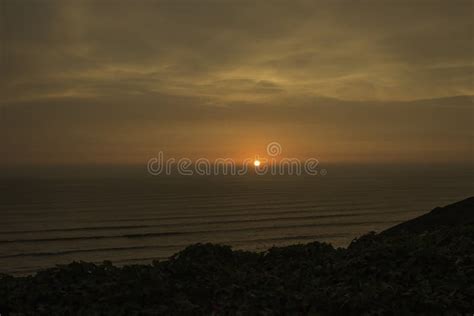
xmin=0 ymin=0 xmax=474 ymax=165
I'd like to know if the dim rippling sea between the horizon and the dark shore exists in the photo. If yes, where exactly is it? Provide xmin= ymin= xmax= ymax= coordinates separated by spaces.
xmin=0 ymin=165 xmax=474 ymax=274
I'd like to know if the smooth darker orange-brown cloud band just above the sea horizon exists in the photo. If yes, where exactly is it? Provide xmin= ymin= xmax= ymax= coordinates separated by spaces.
xmin=0 ymin=94 xmax=474 ymax=163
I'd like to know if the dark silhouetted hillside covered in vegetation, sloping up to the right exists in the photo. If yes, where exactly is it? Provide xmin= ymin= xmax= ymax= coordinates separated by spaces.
xmin=0 ymin=197 xmax=474 ymax=316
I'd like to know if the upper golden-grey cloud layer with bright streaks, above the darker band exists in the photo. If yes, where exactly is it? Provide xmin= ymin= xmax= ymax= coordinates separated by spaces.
xmin=3 ymin=1 xmax=473 ymax=101
